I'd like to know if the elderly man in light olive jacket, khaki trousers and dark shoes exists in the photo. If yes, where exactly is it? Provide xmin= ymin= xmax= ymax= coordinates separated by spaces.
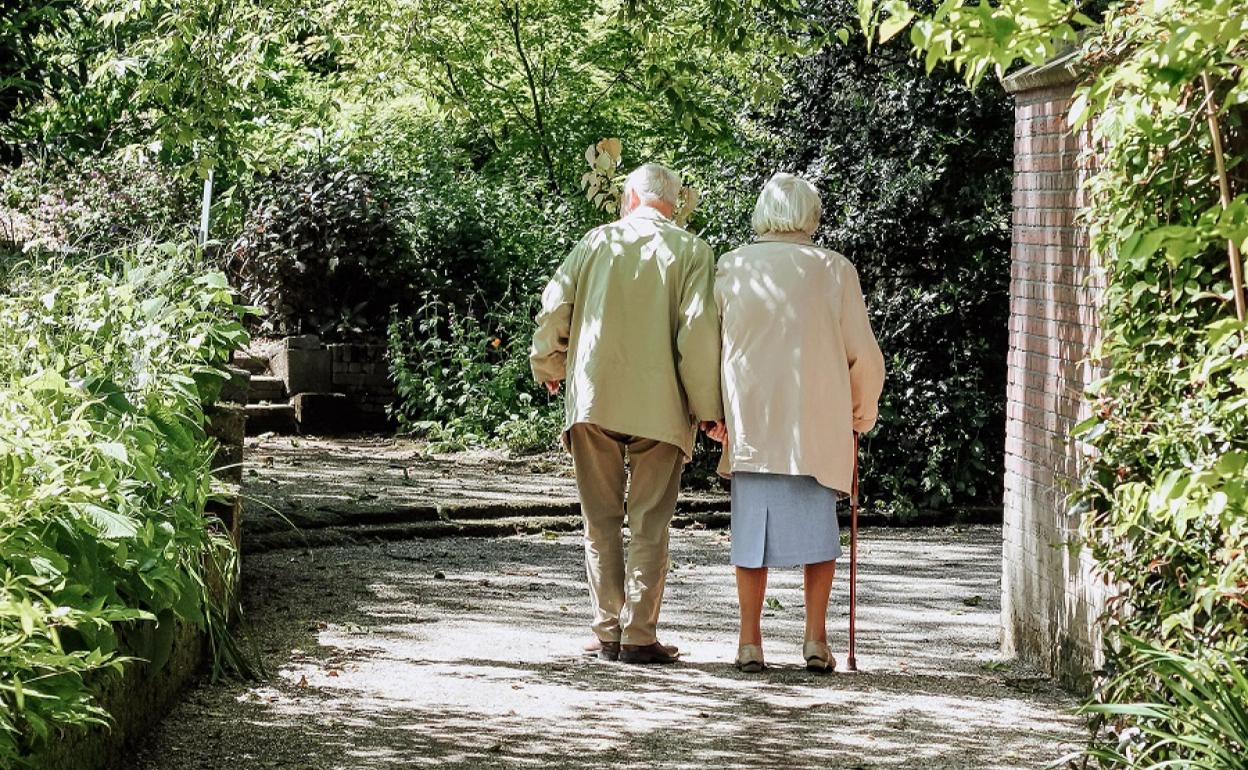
xmin=530 ymin=163 xmax=724 ymax=663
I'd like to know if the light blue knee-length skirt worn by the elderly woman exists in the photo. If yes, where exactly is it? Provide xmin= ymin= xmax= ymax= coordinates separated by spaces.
xmin=731 ymin=473 xmax=841 ymax=568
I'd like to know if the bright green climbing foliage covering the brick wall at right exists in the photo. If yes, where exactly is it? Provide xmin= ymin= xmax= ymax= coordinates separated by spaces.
xmin=866 ymin=0 xmax=1248 ymax=769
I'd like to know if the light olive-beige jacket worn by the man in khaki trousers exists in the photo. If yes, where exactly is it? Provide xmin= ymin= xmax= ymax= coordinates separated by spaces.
xmin=529 ymin=206 xmax=724 ymax=457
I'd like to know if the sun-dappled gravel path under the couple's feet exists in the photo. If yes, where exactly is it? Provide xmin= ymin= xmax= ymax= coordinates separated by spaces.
xmin=124 ymin=527 xmax=1082 ymax=770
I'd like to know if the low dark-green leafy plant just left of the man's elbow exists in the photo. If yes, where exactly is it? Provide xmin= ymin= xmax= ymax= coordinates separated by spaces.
xmin=388 ymin=293 xmax=563 ymax=452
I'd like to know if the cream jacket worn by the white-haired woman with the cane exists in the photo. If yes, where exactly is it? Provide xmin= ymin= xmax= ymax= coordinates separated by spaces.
xmin=715 ymin=233 xmax=884 ymax=492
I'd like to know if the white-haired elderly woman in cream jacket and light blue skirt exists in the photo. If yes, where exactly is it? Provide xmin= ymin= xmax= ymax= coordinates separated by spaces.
xmin=715 ymin=173 xmax=884 ymax=673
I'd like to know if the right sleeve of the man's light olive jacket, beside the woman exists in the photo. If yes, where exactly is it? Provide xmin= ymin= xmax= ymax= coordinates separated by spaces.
xmin=676 ymin=241 xmax=724 ymax=422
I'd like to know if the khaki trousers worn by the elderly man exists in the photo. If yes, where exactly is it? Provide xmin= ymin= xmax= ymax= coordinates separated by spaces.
xmin=568 ymin=423 xmax=684 ymax=645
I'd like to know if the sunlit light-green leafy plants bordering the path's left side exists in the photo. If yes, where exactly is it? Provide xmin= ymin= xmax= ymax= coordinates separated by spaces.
xmin=0 ymin=247 xmax=246 ymax=768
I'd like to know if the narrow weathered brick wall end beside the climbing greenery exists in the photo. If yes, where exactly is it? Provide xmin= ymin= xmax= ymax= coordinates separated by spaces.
xmin=1001 ymin=70 xmax=1103 ymax=688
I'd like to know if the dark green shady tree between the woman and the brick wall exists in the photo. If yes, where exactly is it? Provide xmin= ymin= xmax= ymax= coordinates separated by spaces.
xmin=764 ymin=1 xmax=1013 ymax=513
